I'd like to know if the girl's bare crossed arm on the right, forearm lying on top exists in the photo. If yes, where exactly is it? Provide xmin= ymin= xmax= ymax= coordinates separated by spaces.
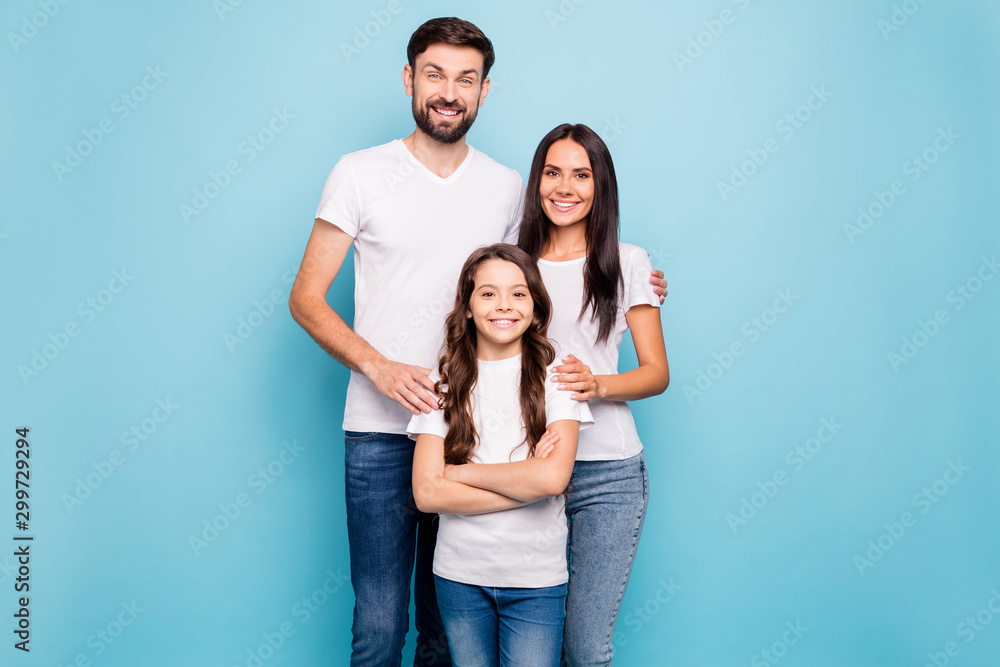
xmin=444 ymin=419 xmax=580 ymax=503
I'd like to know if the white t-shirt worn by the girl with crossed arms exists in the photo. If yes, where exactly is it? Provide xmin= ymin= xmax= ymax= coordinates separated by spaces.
xmin=407 ymin=355 xmax=593 ymax=588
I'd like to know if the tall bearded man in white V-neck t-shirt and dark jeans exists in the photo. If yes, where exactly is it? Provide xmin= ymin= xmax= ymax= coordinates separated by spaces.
xmin=289 ymin=18 xmax=665 ymax=666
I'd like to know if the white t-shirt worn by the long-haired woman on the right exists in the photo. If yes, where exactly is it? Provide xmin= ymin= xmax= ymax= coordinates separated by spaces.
xmin=538 ymin=243 xmax=660 ymax=461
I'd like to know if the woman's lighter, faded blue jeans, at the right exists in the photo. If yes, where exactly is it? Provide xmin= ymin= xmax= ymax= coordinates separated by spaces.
xmin=563 ymin=452 xmax=649 ymax=667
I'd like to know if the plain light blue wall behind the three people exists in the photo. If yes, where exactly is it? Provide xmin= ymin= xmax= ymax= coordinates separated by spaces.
xmin=0 ymin=0 xmax=1000 ymax=667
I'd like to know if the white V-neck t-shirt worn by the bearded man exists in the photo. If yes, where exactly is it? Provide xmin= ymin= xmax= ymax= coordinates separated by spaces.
xmin=316 ymin=139 xmax=524 ymax=433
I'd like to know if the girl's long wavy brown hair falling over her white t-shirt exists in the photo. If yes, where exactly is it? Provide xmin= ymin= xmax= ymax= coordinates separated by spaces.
xmin=434 ymin=243 xmax=556 ymax=464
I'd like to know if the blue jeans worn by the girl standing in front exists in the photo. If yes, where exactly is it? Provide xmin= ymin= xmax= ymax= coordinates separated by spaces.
xmin=435 ymin=577 xmax=566 ymax=667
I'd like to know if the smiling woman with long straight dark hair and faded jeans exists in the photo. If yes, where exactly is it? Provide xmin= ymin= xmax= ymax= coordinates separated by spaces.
xmin=458 ymin=124 xmax=670 ymax=666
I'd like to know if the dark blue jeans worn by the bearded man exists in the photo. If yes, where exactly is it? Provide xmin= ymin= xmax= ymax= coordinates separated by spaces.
xmin=344 ymin=431 xmax=451 ymax=667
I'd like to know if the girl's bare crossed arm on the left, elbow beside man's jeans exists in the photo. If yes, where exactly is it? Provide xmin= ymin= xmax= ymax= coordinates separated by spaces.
xmin=413 ymin=433 xmax=528 ymax=514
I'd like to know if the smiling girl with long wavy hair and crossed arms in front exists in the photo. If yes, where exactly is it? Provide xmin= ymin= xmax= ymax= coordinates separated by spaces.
xmin=407 ymin=243 xmax=590 ymax=667
